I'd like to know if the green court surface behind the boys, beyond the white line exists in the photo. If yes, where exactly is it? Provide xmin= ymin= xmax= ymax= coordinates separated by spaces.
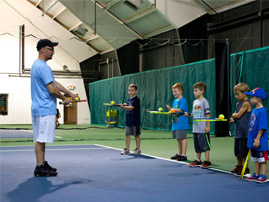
xmin=0 ymin=125 xmax=269 ymax=176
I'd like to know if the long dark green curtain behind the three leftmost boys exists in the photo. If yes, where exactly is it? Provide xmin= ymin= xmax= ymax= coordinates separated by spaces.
xmin=89 ymin=59 xmax=215 ymax=131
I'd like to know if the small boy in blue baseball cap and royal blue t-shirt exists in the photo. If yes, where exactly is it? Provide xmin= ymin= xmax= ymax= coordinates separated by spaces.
xmin=245 ymin=88 xmax=269 ymax=183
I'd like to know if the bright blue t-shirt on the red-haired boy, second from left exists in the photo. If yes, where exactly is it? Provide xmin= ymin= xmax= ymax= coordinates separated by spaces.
xmin=172 ymin=97 xmax=189 ymax=131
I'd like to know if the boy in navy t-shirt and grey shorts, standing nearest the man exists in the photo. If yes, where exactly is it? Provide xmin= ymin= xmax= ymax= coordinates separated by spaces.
xmin=120 ymin=84 xmax=141 ymax=155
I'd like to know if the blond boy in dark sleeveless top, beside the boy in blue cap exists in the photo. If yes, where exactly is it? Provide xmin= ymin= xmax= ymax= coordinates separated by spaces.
xmin=230 ymin=83 xmax=252 ymax=175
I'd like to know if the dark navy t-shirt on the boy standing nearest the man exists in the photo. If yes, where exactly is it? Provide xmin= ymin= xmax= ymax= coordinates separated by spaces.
xmin=125 ymin=96 xmax=140 ymax=126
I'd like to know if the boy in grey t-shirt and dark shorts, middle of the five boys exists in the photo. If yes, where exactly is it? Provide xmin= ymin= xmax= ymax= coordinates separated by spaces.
xmin=189 ymin=82 xmax=211 ymax=168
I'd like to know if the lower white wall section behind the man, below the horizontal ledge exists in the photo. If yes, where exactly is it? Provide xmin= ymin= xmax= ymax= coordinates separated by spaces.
xmin=0 ymin=74 xmax=90 ymax=125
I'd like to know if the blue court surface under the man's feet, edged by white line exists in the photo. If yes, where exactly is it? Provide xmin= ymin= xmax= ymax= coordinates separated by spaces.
xmin=0 ymin=145 xmax=269 ymax=202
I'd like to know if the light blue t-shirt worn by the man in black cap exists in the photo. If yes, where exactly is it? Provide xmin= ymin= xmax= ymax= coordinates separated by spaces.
xmin=31 ymin=59 xmax=57 ymax=116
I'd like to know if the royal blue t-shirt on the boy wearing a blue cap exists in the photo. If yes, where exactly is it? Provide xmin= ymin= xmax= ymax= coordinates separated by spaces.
xmin=248 ymin=107 xmax=268 ymax=151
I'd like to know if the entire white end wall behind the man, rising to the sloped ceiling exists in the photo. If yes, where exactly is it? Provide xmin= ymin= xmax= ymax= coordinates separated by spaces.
xmin=0 ymin=0 xmax=90 ymax=124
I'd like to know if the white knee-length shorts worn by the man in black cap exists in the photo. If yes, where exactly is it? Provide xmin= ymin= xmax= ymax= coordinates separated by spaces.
xmin=32 ymin=115 xmax=56 ymax=143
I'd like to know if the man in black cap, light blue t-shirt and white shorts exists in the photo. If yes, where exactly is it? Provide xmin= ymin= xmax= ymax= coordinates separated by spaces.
xmin=31 ymin=39 xmax=77 ymax=177
